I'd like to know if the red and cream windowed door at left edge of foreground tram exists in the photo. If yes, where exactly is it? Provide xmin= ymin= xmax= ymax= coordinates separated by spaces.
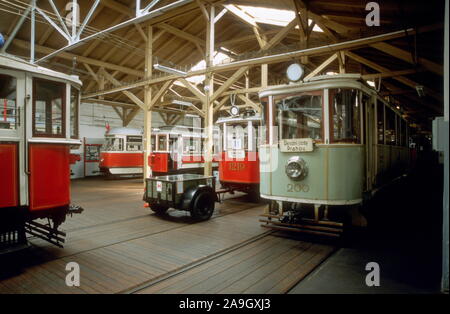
xmin=0 ymin=69 xmax=27 ymax=210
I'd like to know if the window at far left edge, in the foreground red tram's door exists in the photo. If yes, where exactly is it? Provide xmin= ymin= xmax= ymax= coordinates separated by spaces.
xmin=0 ymin=74 xmax=17 ymax=129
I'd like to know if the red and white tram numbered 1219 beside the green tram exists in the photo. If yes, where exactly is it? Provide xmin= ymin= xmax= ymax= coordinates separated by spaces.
xmin=216 ymin=111 xmax=261 ymax=194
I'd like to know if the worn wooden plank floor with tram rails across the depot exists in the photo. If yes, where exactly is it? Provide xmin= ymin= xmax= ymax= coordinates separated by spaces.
xmin=0 ymin=178 xmax=333 ymax=293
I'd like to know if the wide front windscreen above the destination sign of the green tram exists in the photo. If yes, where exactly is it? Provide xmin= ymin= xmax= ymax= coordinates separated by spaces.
xmin=276 ymin=93 xmax=323 ymax=142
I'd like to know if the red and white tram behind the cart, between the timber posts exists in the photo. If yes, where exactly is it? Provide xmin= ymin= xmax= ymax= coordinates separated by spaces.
xmin=148 ymin=126 xmax=219 ymax=175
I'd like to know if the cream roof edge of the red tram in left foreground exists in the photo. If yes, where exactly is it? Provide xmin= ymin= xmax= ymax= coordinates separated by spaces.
xmin=0 ymin=53 xmax=83 ymax=87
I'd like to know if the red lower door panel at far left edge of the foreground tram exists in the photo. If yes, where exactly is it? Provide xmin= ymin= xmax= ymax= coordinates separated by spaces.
xmin=0 ymin=143 xmax=19 ymax=208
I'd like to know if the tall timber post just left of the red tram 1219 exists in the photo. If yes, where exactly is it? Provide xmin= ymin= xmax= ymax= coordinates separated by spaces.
xmin=203 ymin=5 xmax=215 ymax=176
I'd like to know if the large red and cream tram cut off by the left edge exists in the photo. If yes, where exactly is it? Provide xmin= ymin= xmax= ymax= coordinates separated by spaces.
xmin=0 ymin=54 xmax=81 ymax=252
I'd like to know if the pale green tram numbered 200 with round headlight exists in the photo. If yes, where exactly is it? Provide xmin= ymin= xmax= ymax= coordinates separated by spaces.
xmin=259 ymin=74 xmax=410 ymax=236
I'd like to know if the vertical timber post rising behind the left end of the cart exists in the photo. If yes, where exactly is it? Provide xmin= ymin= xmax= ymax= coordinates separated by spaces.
xmin=143 ymin=26 xmax=153 ymax=182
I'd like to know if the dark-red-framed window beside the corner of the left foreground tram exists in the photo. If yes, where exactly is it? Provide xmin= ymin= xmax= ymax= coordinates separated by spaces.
xmin=33 ymin=79 xmax=66 ymax=137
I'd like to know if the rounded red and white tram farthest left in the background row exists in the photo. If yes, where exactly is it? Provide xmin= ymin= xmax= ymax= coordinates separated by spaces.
xmin=100 ymin=128 xmax=144 ymax=176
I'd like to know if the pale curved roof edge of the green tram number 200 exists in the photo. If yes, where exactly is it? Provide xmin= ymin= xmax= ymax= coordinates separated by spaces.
xmin=259 ymin=74 xmax=376 ymax=98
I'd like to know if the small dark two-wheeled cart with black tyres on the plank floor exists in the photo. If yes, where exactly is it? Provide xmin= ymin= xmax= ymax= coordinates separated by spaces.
xmin=144 ymin=174 xmax=218 ymax=220
